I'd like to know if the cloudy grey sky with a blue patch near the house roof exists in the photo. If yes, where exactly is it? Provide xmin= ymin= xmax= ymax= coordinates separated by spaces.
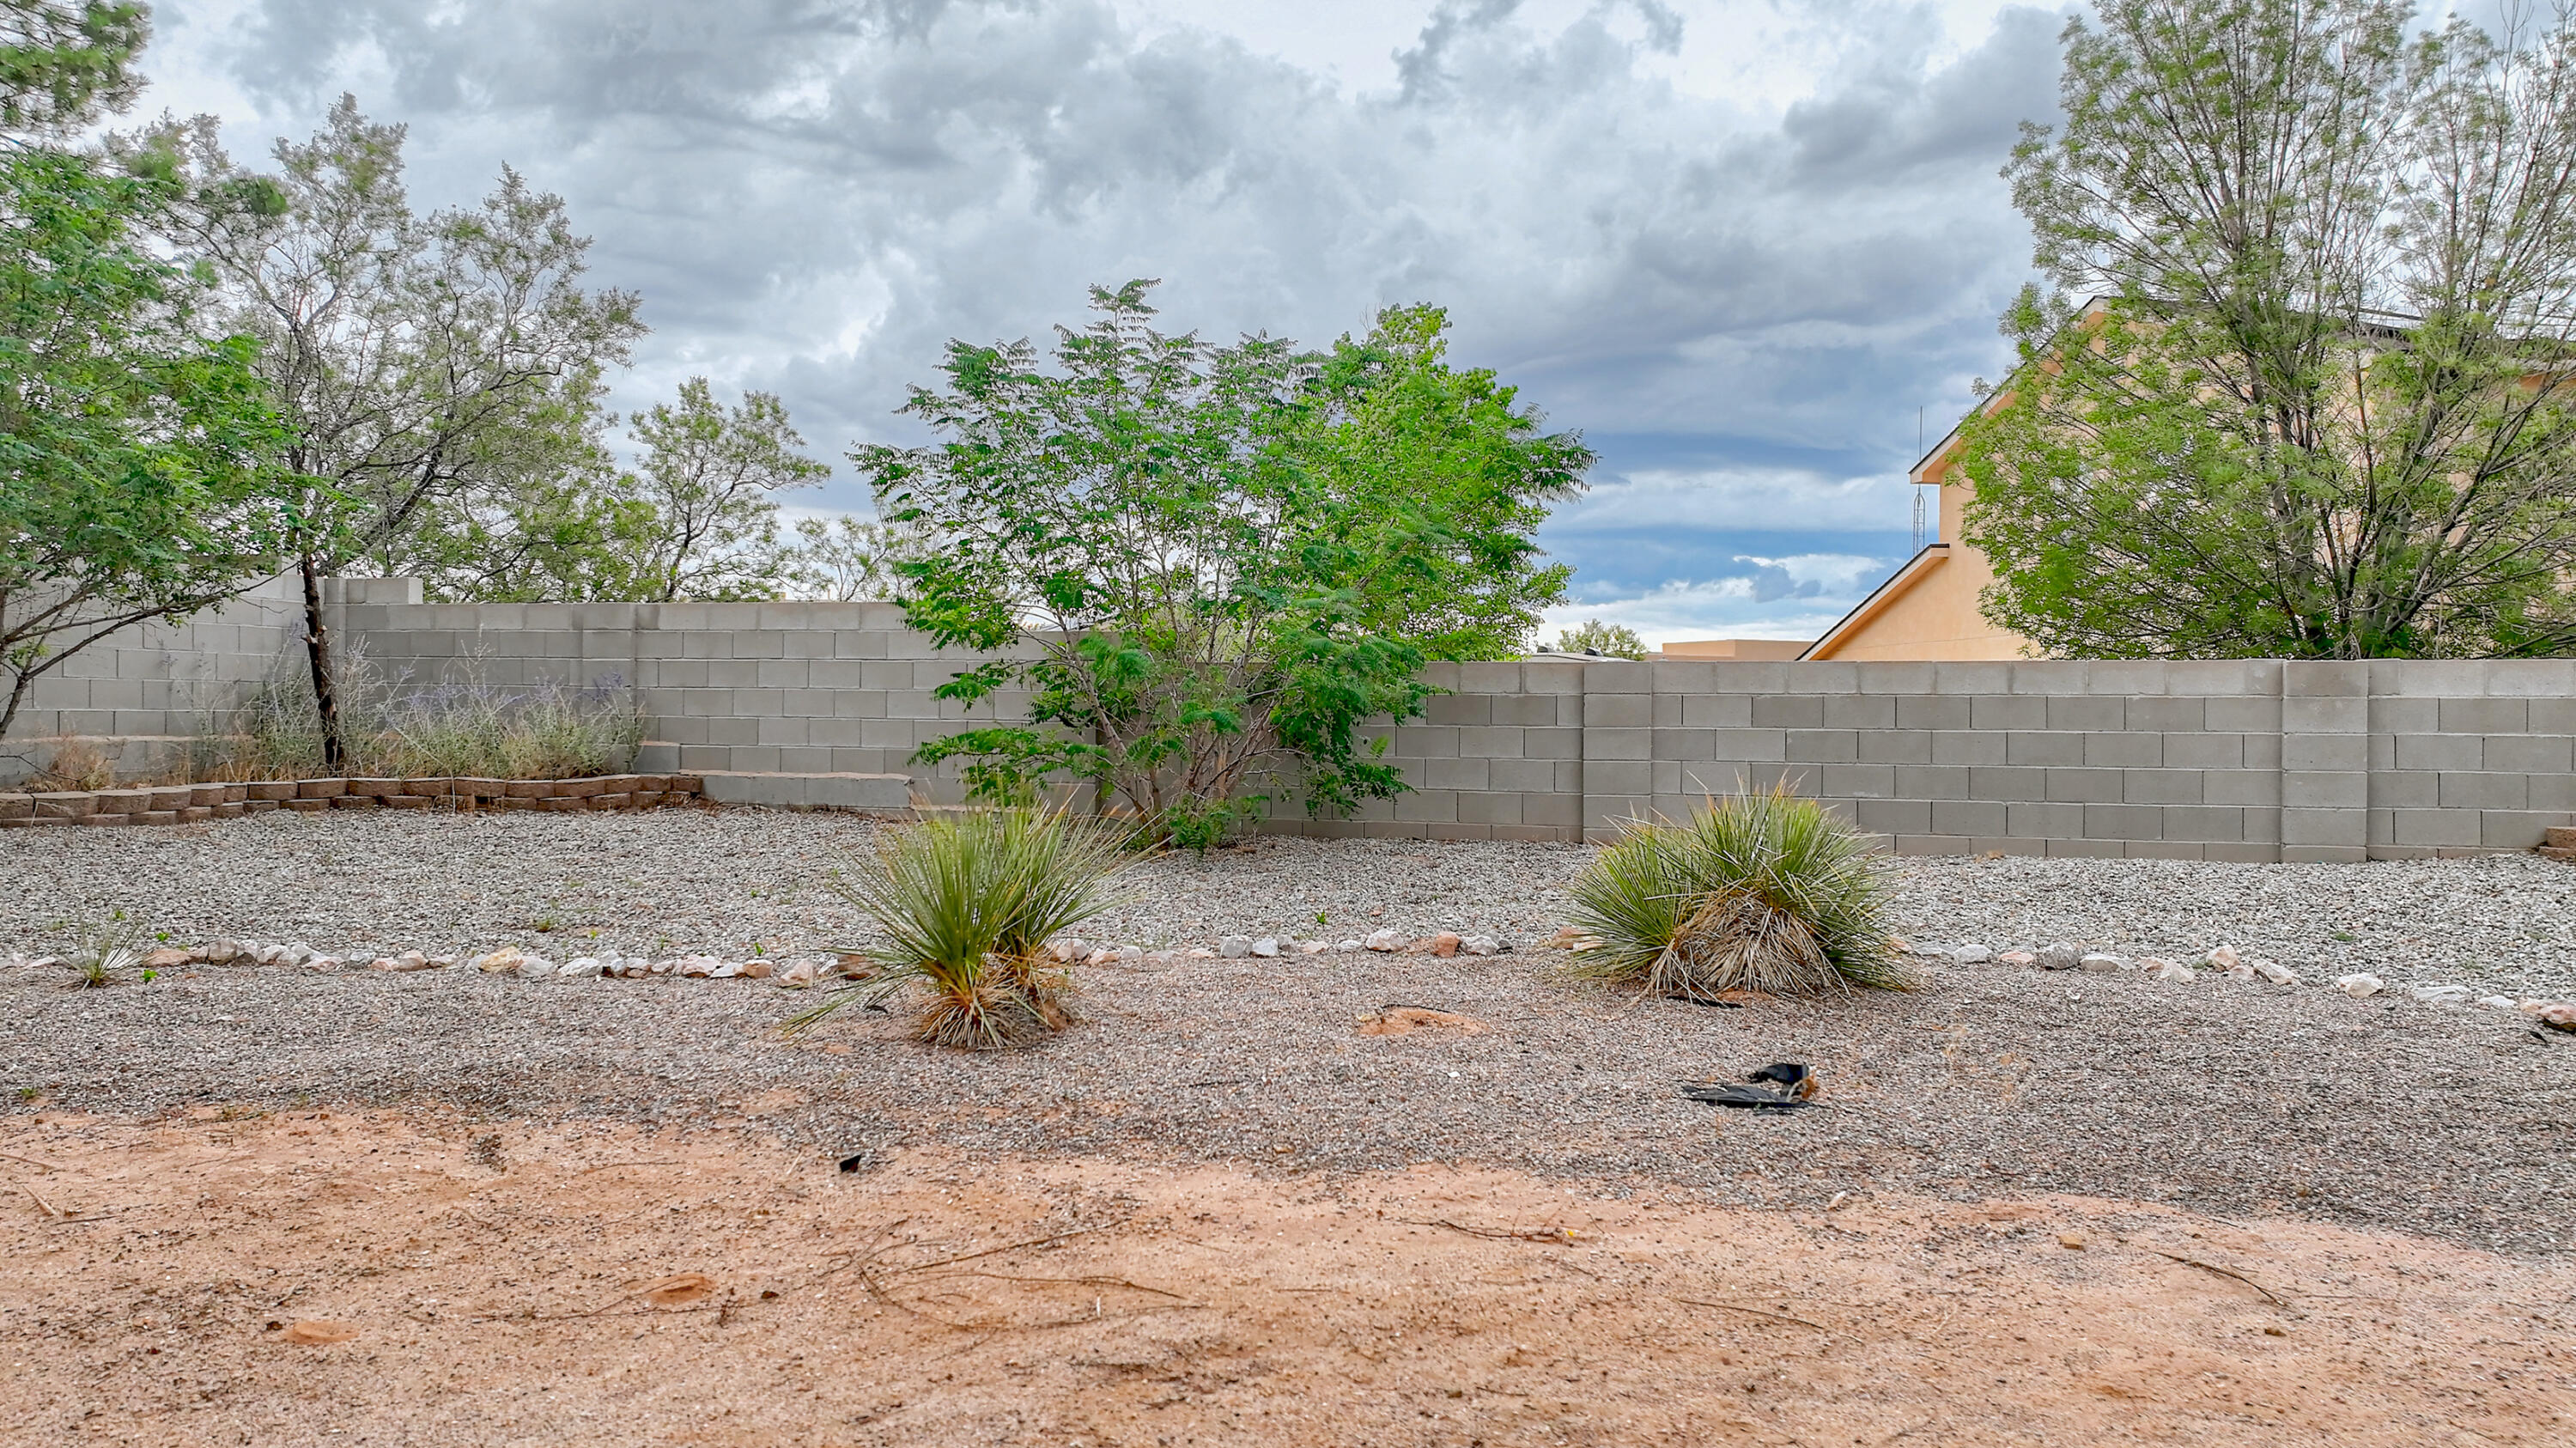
xmin=137 ymin=0 xmax=2063 ymax=639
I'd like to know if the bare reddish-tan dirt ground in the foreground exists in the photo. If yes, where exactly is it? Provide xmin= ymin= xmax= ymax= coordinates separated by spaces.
xmin=0 ymin=1103 xmax=2576 ymax=1448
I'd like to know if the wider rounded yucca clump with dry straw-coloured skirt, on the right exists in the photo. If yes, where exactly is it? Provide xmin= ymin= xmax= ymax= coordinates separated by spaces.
xmin=1571 ymin=788 xmax=1911 ymax=1000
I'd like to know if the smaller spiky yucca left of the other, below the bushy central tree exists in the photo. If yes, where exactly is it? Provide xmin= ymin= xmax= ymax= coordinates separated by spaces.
xmin=791 ymin=809 xmax=1126 ymax=1051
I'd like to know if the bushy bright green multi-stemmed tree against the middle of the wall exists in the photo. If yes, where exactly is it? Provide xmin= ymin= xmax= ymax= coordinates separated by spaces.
xmin=850 ymin=281 xmax=1589 ymax=845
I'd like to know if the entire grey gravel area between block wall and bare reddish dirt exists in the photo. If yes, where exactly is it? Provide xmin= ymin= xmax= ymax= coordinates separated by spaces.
xmin=0 ymin=812 xmax=2576 ymax=1252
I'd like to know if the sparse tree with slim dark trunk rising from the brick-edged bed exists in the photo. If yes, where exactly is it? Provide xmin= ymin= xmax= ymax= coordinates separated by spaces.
xmin=134 ymin=95 xmax=644 ymax=768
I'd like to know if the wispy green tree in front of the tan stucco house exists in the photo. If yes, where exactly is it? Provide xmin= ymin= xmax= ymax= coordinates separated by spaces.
xmin=1965 ymin=0 xmax=2576 ymax=657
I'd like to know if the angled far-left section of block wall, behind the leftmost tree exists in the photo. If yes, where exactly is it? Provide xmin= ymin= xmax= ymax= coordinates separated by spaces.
xmin=0 ymin=577 xmax=307 ymax=783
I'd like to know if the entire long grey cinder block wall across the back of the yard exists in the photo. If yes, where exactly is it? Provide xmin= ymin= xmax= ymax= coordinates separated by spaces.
xmin=30 ymin=580 xmax=2576 ymax=861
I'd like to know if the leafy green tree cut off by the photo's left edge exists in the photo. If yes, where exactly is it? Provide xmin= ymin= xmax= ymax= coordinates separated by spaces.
xmin=0 ymin=3 xmax=301 ymax=732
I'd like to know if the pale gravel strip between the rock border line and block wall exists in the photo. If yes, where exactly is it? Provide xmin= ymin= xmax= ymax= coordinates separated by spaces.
xmin=0 ymin=809 xmax=2576 ymax=997
